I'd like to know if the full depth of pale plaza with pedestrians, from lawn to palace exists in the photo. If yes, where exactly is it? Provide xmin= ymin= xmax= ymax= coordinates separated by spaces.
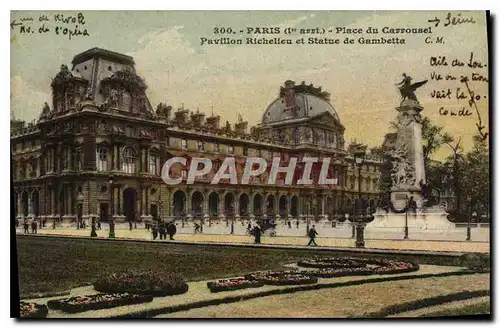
xmin=17 ymin=223 xmax=490 ymax=253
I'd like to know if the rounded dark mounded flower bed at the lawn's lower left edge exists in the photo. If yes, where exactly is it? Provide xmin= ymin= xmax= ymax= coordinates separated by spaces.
xmin=94 ymin=271 xmax=189 ymax=296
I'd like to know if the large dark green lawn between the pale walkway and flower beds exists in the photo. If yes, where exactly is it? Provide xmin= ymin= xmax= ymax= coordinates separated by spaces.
xmin=13 ymin=236 xmax=336 ymax=295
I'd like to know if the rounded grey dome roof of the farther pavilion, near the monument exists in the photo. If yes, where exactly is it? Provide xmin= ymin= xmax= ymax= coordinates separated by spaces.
xmin=262 ymin=81 xmax=340 ymax=124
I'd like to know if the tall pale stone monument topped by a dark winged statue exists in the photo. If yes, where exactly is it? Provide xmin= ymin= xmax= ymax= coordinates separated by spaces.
xmin=367 ymin=74 xmax=453 ymax=231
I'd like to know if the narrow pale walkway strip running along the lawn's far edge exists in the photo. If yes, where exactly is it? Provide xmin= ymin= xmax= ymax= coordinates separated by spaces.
xmin=18 ymin=227 xmax=490 ymax=253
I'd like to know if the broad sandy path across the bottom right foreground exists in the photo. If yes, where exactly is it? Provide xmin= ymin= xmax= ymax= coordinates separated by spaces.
xmin=157 ymin=274 xmax=490 ymax=319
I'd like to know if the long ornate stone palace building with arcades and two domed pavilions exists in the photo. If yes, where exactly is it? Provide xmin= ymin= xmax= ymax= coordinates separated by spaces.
xmin=11 ymin=48 xmax=381 ymax=227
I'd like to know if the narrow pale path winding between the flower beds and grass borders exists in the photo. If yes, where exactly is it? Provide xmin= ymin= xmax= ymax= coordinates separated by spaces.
xmin=27 ymin=265 xmax=462 ymax=318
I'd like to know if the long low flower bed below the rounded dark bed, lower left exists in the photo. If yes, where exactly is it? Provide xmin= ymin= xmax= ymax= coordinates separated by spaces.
xmin=47 ymin=293 xmax=153 ymax=313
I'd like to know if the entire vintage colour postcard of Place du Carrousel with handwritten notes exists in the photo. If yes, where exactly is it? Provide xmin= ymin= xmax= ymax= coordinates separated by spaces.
xmin=10 ymin=11 xmax=492 ymax=319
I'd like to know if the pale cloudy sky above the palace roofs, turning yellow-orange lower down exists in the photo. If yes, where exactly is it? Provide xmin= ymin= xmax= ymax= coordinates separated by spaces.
xmin=10 ymin=11 xmax=488 ymax=159
